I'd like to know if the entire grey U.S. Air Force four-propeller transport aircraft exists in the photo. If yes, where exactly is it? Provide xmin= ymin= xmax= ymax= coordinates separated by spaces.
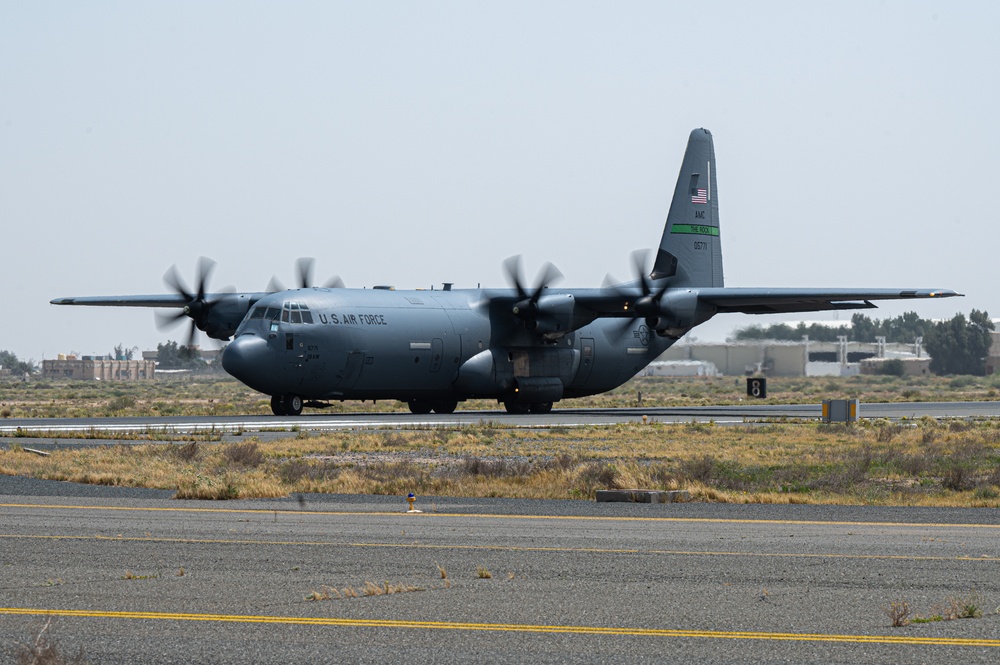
xmin=52 ymin=129 xmax=960 ymax=415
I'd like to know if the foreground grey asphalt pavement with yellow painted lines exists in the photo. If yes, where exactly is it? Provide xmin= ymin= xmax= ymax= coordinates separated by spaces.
xmin=0 ymin=490 xmax=1000 ymax=663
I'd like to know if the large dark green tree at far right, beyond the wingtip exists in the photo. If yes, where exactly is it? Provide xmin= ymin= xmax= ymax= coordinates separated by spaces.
xmin=924 ymin=309 xmax=994 ymax=376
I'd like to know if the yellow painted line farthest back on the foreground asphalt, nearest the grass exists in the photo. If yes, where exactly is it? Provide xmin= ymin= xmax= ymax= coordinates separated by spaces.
xmin=0 ymin=499 xmax=1000 ymax=529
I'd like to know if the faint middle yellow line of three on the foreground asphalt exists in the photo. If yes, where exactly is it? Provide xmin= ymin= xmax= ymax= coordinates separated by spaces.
xmin=0 ymin=533 xmax=1000 ymax=563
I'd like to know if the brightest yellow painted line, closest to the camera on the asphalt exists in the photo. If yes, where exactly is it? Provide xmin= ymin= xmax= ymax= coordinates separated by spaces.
xmin=0 ymin=607 xmax=1000 ymax=648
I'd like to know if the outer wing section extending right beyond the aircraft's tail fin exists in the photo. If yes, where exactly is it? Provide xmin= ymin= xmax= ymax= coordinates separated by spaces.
xmin=688 ymin=287 xmax=962 ymax=314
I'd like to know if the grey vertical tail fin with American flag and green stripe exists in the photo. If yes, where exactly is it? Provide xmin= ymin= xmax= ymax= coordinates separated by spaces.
xmin=650 ymin=129 xmax=724 ymax=287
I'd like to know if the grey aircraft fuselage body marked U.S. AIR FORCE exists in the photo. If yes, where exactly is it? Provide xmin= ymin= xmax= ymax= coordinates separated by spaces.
xmin=223 ymin=288 xmax=675 ymax=402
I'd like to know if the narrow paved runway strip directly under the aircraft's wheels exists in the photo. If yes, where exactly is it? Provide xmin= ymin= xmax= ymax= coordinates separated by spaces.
xmin=0 ymin=402 xmax=1000 ymax=436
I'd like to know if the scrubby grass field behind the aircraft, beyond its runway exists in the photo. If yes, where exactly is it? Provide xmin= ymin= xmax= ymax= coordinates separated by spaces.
xmin=0 ymin=374 xmax=1000 ymax=419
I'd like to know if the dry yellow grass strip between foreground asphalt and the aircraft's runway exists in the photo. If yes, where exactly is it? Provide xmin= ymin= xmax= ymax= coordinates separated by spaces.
xmin=0 ymin=417 xmax=1000 ymax=507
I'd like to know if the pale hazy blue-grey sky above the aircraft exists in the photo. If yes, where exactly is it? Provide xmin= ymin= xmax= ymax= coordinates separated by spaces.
xmin=0 ymin=0 xmax=1000 ymax=360
